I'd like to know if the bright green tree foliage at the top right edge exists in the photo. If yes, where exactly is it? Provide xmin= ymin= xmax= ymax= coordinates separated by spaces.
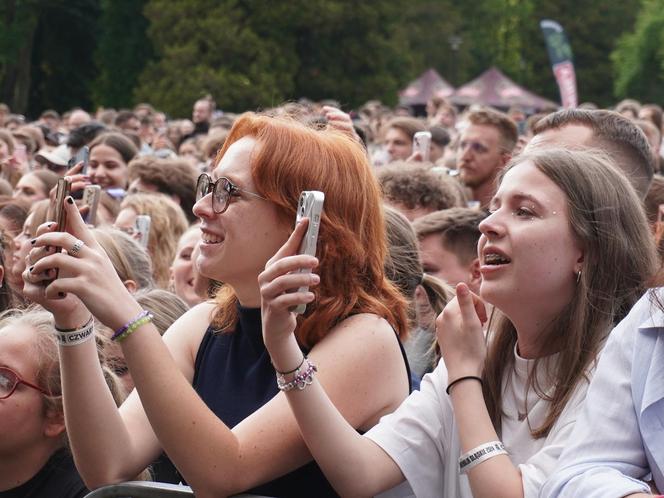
xmin=612 ymin=0 xmax=664 ymax=103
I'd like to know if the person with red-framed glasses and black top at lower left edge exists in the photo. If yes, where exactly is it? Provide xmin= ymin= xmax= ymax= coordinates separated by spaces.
xmin=0 ymin=309 xmax=87 ymax=498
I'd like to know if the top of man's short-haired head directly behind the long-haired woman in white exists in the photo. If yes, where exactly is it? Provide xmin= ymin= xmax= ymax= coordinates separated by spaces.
xmin=524 ymin=109 xmax=654 ymax=199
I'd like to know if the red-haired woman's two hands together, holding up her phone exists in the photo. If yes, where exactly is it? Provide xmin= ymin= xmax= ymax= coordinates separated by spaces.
xmin=23 ymin=197 xmax=140 ymax=329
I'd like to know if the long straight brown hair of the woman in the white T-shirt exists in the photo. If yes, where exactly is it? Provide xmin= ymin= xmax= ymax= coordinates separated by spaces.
xmin=483 ymin=148 xmax=656 ymax=438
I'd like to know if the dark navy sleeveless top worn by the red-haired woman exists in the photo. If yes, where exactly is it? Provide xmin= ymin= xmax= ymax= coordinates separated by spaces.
xmin=160 ymin=306 xmax=411 ymax=497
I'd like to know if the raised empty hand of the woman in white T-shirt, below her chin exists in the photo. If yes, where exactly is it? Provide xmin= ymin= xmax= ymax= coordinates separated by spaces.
xmin=436 ymin=283 xmax=487 ymax=379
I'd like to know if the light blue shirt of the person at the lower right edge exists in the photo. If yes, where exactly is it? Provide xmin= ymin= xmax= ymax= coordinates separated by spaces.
xmin=540 ymin=288 xmax=664 ymax=498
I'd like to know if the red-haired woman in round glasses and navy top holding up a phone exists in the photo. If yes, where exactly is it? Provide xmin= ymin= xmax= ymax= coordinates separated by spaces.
xmin=25 ymin=114 xmax=409 ymax=496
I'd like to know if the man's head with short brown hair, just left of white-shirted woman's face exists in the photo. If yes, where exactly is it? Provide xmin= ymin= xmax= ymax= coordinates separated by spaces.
xmin=413 ymin=207 xmax=486 ymax=294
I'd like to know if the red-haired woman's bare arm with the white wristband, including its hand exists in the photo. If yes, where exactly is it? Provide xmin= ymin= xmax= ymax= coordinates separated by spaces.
xmin=24 ymin=219 xmax=167 ymax=488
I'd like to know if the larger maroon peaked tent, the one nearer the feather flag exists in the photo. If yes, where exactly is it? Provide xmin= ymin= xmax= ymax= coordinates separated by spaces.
xmin=450 ymin=67 xmax=560 ymax=111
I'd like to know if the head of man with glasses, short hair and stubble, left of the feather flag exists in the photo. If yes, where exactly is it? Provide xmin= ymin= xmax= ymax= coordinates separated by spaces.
xmin=457 ymin=108 xmax=518 ymax=208
